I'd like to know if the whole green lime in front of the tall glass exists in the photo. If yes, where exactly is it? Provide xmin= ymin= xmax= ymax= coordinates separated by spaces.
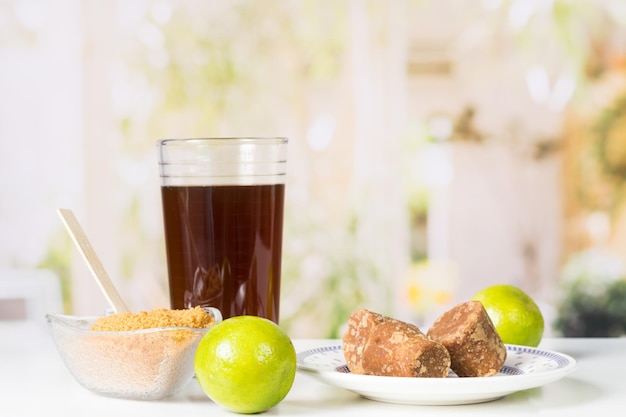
xmin=194 ymin=316 xmax=296 ymax=414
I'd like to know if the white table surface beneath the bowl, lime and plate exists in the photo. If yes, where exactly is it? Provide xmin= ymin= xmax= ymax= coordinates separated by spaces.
xmin=0 ymin=321 xmax=626 ymax=417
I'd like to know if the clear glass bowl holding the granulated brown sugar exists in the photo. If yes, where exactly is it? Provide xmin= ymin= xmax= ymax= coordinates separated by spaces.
xmin=46 ymin=308 xmax=222 ymax=400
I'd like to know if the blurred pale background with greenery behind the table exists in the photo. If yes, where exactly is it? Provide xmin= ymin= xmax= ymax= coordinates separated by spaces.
xmin=0 ymin=0 xmax=626 ymax=337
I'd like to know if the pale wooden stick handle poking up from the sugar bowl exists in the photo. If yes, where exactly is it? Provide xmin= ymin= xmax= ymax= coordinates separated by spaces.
xmin=57 ymin=208 xmax=128 ymax=313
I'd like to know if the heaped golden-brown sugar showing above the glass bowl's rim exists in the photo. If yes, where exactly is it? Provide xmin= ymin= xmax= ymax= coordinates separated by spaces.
xmin=91 ymin=306 xmax=215 ymax=332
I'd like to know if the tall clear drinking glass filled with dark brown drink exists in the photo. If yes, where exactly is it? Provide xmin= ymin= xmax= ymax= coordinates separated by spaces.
xmin=157 ymin=137 xmax=287 ymax=323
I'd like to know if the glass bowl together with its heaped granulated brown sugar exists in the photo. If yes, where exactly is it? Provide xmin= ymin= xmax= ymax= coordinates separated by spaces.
xmin=48 ymin=307 xmax=216 ymax=399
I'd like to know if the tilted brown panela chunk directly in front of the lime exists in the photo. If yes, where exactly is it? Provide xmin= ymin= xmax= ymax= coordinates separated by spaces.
xmin=428 ymin=301 xmax=506 ymax=377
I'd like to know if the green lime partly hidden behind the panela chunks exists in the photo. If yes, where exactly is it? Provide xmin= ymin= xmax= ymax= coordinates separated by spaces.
xmin=472 ymin=284 xmax=544 ymax=347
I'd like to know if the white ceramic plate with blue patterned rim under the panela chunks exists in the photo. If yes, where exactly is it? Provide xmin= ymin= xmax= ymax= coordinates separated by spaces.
xmin=297 ymin=345 xmax=576 ymax=405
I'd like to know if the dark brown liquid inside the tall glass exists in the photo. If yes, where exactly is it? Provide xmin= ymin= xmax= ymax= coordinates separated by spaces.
xmin=161 ymin=184 xmax=285 ymax=323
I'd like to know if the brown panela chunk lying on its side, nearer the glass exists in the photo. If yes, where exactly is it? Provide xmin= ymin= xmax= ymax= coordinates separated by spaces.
xmin=343 ymin=309 xmax=450 ymax=378
